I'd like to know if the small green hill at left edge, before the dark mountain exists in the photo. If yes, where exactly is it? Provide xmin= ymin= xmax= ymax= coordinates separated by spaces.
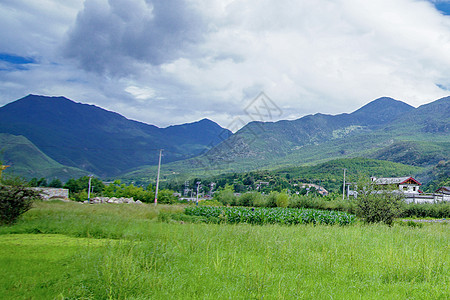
xmin=0 ymin=133 xmax=89 ymax=181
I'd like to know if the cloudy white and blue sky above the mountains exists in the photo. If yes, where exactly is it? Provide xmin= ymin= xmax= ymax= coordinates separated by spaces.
xmin=0 ymin=0 xmax=450 ymax=127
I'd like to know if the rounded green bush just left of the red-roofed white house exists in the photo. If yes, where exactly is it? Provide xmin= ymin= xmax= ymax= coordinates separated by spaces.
xmin=356 ymin=184 xmax=405 ymax=225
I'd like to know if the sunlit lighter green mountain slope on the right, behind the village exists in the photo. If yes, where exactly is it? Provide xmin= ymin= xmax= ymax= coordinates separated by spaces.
xmin=124 ymin=97 xmax=450 ymax=183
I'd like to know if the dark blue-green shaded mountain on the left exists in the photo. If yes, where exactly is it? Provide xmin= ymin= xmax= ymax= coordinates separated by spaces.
xmin=0 ymin=95 xmax=231 ymax=177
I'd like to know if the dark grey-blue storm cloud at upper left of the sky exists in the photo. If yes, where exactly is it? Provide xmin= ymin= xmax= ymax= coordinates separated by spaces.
xmin=64 ymin=0 xmax=206 ymax=74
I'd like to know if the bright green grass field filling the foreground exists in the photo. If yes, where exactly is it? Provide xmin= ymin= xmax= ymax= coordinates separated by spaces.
xmin=0 ymin=202 xmax=450 ymax=299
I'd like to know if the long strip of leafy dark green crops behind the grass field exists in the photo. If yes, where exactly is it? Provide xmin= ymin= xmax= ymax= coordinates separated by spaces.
xmin=185 ymin=206 xmax=355 ymax=225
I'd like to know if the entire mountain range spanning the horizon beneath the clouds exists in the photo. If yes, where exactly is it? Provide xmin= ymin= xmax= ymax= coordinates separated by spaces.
xmin=0 ymin=95 xmax=450 ymax=180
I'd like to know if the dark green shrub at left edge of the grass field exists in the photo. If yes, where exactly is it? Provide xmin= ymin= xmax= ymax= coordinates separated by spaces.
xmin=0 ymin=184 xmax=40 ymax=224
